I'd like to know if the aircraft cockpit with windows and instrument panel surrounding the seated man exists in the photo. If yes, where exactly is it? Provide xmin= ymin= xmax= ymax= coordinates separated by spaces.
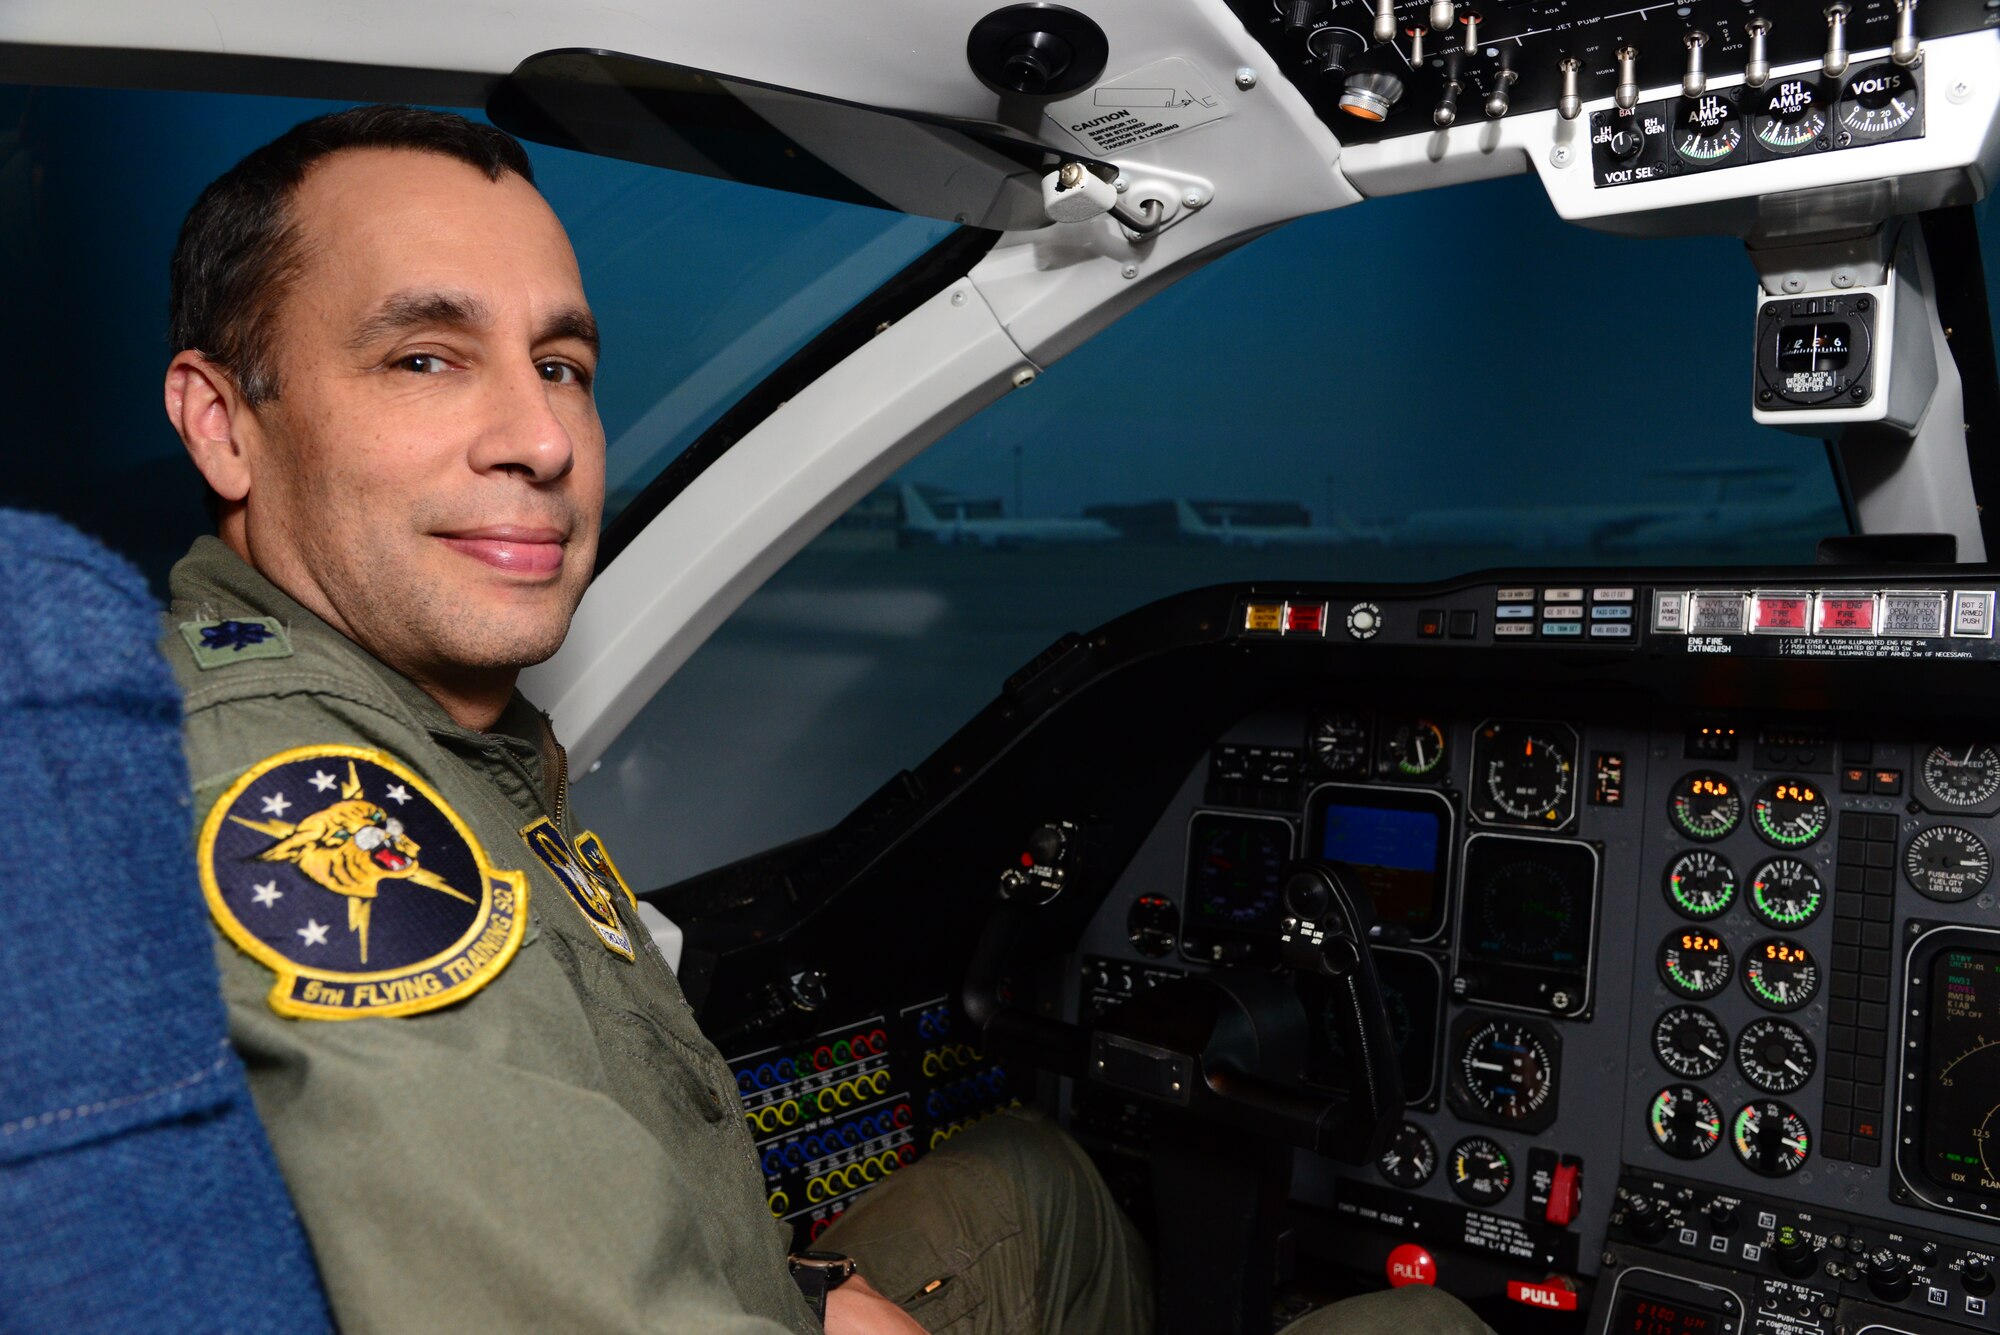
xmin=11 ymin=0 xmax=2000 ymax=1335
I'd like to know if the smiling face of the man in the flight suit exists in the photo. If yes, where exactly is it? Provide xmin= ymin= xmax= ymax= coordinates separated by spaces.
xmin=244 ymin=150 xmax=604 ymax=683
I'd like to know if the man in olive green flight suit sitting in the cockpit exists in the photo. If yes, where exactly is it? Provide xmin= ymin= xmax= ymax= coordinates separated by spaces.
xmin=166 ymin=108 xmax=1488 ymax=1335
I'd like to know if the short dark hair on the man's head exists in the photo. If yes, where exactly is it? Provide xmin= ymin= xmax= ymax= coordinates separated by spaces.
xmin=166 ymin=106 xmax=534 ymax=404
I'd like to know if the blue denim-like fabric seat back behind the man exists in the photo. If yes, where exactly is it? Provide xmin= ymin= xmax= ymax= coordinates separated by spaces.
xmin=0 ymin=510 xmax=330 ymax=1335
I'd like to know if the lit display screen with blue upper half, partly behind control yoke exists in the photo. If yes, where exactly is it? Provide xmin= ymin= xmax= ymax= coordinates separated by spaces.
xmin=1308 ymin=783 xmax=1452 ymax=941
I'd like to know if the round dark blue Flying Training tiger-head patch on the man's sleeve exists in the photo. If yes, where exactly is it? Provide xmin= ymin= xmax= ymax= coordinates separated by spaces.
xmin=198 ymin=745 xmax=528 ymax=1019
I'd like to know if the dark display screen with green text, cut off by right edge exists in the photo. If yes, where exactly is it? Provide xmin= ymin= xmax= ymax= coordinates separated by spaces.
xmin=1920 ymin=949 xmax=2000 ymax=1197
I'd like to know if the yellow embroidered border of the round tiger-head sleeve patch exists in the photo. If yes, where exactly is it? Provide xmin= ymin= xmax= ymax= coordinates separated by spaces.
xmin=194 ymin=743 xmax=528 ymax=1019
